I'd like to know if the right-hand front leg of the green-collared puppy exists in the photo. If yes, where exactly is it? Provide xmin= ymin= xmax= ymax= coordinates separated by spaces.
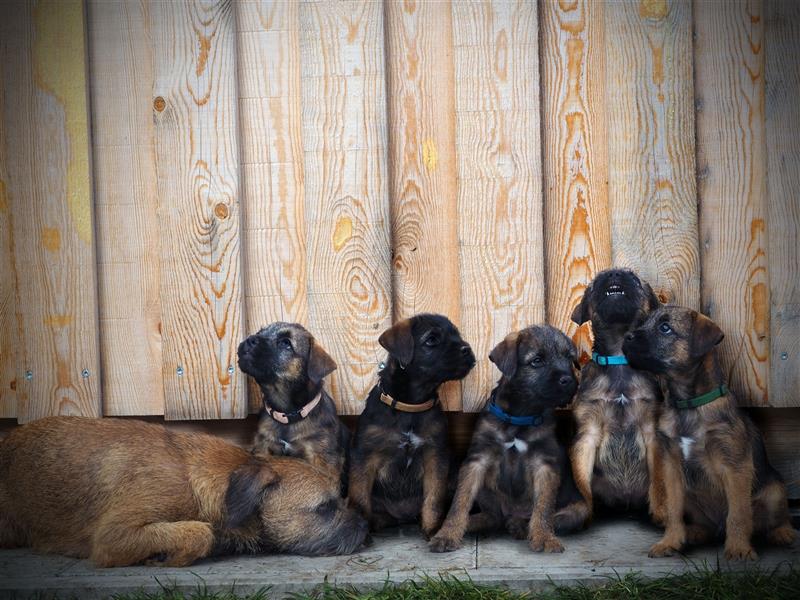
xmin=720 ymin=457 xmax=758 ymax=560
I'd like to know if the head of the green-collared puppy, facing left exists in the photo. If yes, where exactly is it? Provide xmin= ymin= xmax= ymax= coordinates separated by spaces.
xmin=622 ymin=306 xmax=725 ymax=373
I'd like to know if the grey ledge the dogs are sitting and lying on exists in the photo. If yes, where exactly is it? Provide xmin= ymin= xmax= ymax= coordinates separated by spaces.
xmin=0 ymin=519 xmax=800 ymax=598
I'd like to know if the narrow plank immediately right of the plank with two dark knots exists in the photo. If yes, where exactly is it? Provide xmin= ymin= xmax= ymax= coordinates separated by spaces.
xmin=236 ymin=0 xmax=308 ymax=411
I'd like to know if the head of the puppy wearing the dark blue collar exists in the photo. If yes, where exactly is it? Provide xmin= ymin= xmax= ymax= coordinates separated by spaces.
xmin=489 ymin=325 xmax=578 ymax=407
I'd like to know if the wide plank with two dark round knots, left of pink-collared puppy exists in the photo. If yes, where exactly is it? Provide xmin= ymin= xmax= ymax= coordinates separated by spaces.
xmin=150 ymin=0 xmax=247 ymax=419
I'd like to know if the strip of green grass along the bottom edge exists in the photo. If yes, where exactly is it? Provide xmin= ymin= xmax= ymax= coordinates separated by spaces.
xmin=101 ymin=566 xmax=800 ymax=600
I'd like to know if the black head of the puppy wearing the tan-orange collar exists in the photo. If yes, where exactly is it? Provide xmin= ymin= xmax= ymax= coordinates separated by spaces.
xmin=378 ymin=313 xmax=475 ymax=382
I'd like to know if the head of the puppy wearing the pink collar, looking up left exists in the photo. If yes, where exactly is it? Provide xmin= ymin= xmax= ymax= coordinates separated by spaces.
xmin=238 ymin=322 xmax=336 ymax=385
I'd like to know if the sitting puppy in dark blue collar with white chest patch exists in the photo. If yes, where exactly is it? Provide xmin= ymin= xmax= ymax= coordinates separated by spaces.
xmin=429 ymin=325 xmax=587 ymax=552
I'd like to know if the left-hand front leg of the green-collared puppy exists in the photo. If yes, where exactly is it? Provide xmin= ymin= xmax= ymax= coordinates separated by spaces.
xmin=649 ymin=437 xmax=686 ymax=558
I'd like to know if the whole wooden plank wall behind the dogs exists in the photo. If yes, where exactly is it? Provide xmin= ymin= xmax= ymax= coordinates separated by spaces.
xmin=0 ymin=0 xmax=800 ymax=426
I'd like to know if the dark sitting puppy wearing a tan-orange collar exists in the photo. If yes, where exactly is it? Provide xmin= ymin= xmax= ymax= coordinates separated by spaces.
xmin=350 ymin=314 xmax=475 ymax=537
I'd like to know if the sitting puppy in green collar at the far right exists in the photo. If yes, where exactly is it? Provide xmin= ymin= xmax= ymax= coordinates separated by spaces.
xmin=623 ymin=306 xmax=795 ymax=560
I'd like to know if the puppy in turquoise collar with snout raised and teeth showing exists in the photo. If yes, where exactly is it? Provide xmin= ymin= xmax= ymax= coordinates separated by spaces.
xmin=570 ymin=269 xmax=664 ymax=524
